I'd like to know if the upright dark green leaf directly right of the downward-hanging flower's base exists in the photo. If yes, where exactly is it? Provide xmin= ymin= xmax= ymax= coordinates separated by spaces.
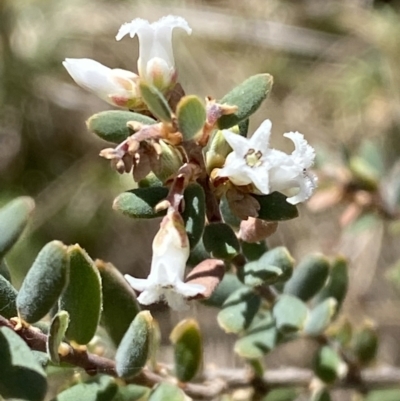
xmin=182 ymin=184 xmax=205 ymax=249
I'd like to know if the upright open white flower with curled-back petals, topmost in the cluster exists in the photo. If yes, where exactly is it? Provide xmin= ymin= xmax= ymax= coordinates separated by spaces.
xmin=116 ymin=15 xmax=192 ymax=91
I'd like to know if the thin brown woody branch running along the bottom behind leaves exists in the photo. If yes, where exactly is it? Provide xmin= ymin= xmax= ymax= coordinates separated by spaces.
xmin=0 ymin=316 xmax=400 ymax=400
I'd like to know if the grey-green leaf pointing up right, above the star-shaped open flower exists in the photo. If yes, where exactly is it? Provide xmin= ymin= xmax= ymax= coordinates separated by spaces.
xmin=218 ymin=74 xmax=273 ymax=129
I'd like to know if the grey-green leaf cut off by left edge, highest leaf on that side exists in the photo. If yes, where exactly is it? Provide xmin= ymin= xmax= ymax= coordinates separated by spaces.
xmin=0 ymin=196 xmax=35 ymax=260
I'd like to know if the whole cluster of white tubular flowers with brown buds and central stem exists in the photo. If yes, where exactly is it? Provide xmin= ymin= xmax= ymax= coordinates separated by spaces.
xmin=64 ymin=16 xmax=317 ymax=310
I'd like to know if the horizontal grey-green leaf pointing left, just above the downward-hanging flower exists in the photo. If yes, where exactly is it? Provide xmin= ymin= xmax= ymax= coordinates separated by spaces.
xmin=113 ymin=187 xmax=168 ymax=219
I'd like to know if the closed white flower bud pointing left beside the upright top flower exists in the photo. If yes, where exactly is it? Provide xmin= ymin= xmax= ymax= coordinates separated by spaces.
xmin=63 ymin=58 xmax=142 ymax=109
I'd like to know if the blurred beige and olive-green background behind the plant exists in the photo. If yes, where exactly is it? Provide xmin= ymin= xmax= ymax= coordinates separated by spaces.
xmin=0 ymin=0 xmax=400 ymax=396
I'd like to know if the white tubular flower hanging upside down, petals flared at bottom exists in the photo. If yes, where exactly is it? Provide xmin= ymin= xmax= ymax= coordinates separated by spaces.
xmin=125 ymin=211 xmax=205 ymax=310
